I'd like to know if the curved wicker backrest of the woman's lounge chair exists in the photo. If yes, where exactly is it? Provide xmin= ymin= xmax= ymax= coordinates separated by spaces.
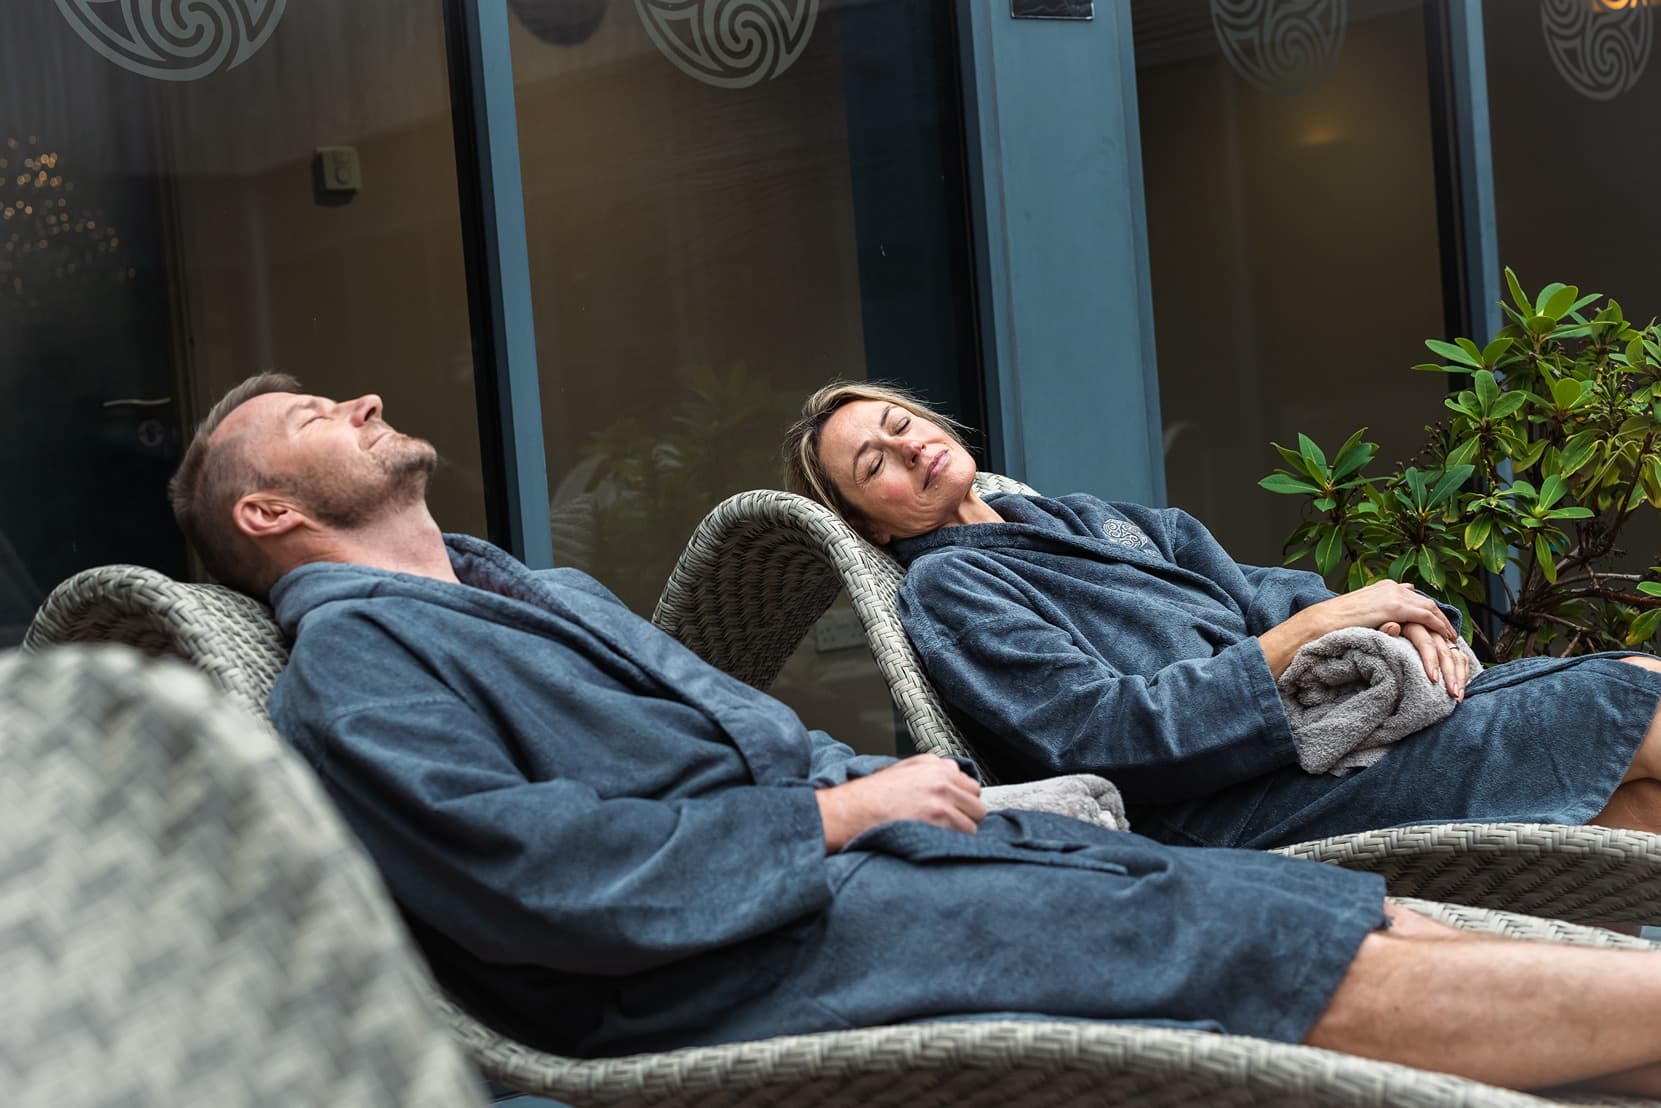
xmin=653 ymin=473 xmax=1033 ymax=781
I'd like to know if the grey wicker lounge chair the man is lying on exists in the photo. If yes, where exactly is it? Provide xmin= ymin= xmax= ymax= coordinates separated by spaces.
xmin=22 ymin=566 xmax=1661 ymax=1108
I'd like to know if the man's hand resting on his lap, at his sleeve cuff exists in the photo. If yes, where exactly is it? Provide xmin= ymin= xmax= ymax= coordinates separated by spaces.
xmin=819 ymin=754 xmax=987 ymax=854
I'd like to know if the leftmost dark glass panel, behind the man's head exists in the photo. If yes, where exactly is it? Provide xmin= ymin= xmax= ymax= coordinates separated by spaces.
xmin=0 ymin=0 xmax=483 ymax=645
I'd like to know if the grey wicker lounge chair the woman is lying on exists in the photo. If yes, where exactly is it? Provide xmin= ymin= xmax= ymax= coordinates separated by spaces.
xmin=653 ymin=473 xmax=1661 ymax=924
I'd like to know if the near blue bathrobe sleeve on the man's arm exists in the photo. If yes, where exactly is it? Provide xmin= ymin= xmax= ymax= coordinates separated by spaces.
xmin=277 ymin=618 xmax=845 ymax=975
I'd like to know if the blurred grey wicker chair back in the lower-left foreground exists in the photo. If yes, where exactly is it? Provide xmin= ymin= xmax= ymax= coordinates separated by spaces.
xmin=0 ymin=646 xmax=485 ymax=1108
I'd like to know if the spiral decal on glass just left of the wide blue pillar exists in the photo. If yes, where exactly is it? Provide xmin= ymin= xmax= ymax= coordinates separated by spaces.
xmin=635 ymin=0 xmax=819 ymax=88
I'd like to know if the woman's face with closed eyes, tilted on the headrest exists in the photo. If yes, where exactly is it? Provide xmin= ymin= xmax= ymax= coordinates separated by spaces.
xmin=819 ymin=400 xmax=975 ymax=543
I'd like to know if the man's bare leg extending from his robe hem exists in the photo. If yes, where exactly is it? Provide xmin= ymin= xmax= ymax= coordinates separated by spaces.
xmin=1306 ymin=909 xmax=1661 ymax=1093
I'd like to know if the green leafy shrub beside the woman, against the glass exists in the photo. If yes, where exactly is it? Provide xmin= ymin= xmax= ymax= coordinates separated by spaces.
xmin=1259 ymin=269 xmax=1661 ymax=661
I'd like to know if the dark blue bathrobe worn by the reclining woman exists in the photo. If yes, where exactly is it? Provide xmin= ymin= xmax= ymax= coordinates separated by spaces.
xmin=892 ymin=495 xmax=1661 ymax=847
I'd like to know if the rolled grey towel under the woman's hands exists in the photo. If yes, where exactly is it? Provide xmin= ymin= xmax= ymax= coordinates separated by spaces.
xmin=1277 ymin=628 xmax=1482 ymax=776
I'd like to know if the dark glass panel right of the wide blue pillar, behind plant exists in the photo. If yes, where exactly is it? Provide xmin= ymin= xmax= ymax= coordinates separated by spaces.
xmin=1133 ymin=0 xmax=1445 ymax=565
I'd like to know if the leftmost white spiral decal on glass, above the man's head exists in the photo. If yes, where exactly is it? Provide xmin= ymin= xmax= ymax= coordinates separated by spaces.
xmin=56 ymin=0 xmax=287 ymax=81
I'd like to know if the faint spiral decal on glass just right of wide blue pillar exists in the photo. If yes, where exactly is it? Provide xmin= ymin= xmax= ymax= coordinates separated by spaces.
xmin=1211 ymin=0 xmax=1347 ymax=96
